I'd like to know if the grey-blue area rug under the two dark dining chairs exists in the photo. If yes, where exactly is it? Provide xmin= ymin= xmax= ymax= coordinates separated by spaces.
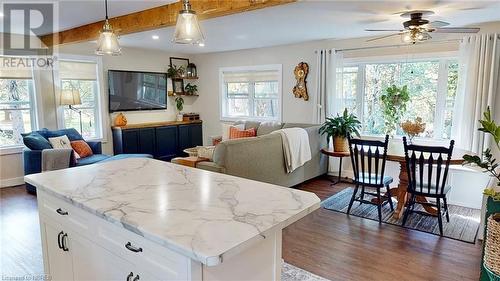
xmin=321 ymin=187 xmax=481 ymax=243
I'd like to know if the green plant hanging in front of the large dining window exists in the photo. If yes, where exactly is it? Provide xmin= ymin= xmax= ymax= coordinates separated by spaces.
xmin=380 ymin=85 xmax=410 ymax=137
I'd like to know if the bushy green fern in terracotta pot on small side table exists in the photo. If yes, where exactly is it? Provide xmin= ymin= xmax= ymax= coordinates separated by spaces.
xmin=319 ymin=108 xmax=361 ymax=152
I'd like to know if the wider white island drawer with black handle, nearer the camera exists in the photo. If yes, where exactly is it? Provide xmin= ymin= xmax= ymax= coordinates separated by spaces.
xmin=98 ymin=220 xmax=190 ymax=280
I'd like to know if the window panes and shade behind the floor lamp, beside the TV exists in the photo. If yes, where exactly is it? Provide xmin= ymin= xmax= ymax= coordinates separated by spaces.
xmin=59 ymin=60 xmax=102 ymax=139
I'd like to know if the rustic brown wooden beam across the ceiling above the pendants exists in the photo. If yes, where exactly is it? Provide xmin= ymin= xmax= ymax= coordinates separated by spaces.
xmin=40 ymin=0 xmax=297 ymax=47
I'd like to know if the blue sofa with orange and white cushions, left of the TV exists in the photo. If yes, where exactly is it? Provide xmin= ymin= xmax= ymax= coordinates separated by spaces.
xmin=23 ymin=128 xmax=153 ymax=194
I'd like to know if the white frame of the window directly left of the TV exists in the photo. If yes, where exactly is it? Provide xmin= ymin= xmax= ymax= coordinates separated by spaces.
xmin=54 ymin=54 xmax=108 ymax=143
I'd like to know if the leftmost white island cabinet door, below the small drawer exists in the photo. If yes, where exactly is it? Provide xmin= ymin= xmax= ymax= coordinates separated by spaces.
xmin=40 ymin=218 xmax=73 ymax=281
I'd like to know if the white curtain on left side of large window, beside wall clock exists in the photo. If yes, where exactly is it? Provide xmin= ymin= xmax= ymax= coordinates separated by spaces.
xmin=312 ymin=49 xmax=342 ymax=124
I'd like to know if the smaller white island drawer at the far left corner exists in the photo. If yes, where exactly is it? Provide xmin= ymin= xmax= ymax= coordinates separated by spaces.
xmin=37 ymin=192 xmax=90 ymax=232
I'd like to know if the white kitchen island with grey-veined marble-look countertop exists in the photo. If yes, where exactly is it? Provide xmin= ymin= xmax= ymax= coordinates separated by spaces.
xmin=25 ymin=158 xmax=320 ymax=281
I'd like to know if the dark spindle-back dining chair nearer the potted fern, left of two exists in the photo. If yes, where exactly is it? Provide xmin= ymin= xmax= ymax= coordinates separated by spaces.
xmin=347 ymin=135 xmax=394 ymax=222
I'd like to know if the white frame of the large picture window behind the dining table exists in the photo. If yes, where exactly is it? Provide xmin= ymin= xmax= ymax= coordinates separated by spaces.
xmin=341 ymin=51 xmax=459 ymax=144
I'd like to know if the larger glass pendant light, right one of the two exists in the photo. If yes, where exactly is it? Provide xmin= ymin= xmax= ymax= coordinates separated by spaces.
xmin=172 ymin=0 xmax=205 ymax=45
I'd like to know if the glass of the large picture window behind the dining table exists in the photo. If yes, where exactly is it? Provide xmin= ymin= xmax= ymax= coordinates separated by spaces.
xmin=339 ymin=54 xmax=458 ymax=139
